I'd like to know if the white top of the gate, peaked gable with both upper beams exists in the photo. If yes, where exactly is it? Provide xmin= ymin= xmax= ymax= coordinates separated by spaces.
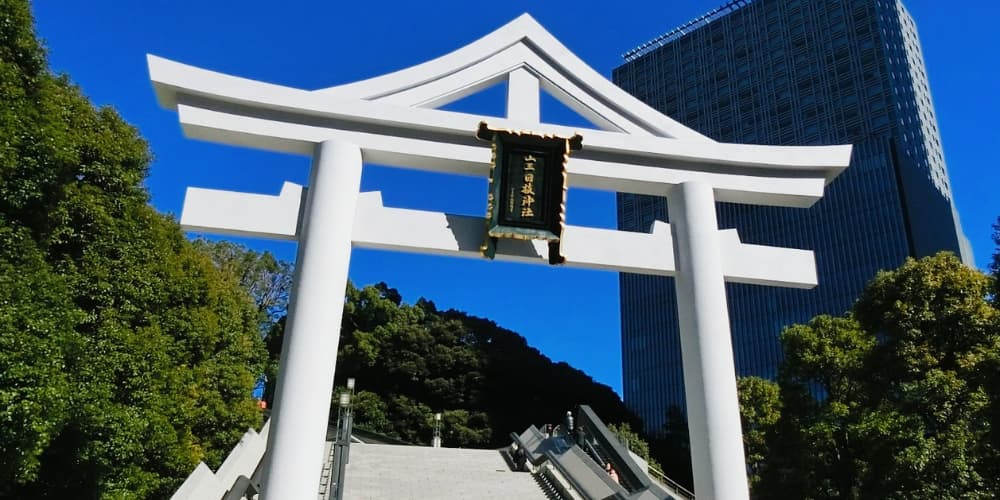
xmin=148 ymin=14 xmax=851 ymax=207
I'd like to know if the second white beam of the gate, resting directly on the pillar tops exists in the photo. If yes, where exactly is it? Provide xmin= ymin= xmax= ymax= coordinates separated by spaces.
xmin=178 ymin=105 xmax=836 ymax=207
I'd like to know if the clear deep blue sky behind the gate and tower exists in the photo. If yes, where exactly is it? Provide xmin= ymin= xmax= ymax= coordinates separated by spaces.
xmin=34 ymin=0 xmax=1000 ymax=393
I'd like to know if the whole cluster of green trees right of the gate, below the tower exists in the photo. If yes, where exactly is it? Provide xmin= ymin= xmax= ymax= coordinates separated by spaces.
xmin=741 ymin=253 xmax=1000 ymax=499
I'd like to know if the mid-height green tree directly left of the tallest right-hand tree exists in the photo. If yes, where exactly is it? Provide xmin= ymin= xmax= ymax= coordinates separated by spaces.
xmin=758 ymin=315 xmax=875 ymax=498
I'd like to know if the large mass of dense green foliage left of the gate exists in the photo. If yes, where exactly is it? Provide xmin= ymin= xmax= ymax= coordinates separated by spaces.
xmin=0 ymin=0 xmax=264 ymax=498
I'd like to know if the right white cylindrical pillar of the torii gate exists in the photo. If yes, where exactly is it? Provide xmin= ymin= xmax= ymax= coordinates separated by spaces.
xmin=667 ymin=182 xmax=750 ymax=499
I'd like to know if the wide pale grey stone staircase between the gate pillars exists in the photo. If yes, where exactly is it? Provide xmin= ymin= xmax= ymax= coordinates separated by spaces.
xmin=344 ymin=443 xmax=549 ymax=500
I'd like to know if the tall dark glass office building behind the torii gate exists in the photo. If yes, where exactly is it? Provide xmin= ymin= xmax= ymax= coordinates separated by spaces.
xmin=614 ymin=0 xmax=972 ymax=431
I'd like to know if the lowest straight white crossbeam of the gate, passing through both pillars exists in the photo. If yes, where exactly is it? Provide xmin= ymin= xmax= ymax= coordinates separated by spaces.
xmin=181 ymin=188 xmax=816 ymax=288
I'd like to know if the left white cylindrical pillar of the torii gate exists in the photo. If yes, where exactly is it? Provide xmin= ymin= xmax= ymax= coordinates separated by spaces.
xmin=262 ymin=140 xmax=362 ymax=499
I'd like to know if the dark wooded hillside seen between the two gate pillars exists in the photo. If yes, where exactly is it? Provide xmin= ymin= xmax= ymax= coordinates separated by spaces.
xmin=292 ymin=283 xmax=641 ymax=447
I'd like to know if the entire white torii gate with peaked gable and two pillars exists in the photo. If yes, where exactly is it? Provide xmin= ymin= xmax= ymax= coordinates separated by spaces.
xmin=148 ymin=14 xmax=851 ymax=500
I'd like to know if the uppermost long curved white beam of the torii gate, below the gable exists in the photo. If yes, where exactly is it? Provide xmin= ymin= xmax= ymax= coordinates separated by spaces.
xmin=148 ymin=55 xmax=851 ymax=180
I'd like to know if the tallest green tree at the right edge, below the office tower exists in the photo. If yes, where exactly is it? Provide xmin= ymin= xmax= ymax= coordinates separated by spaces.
xmin=855 ymin=253 xmax=1000 ymax=498
